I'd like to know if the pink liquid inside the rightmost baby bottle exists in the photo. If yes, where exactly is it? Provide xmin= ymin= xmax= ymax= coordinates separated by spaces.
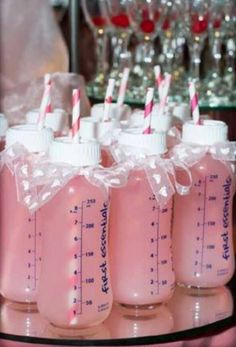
xmin=173 ymin=155 xmax=235 ymax=287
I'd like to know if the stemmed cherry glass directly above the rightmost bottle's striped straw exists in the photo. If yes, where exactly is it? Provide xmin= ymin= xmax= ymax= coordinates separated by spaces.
xmin=185 ymin=0 xmax=209 ymax=92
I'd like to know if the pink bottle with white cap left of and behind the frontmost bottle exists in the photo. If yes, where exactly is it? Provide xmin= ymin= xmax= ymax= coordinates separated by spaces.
xmin=0 ymin=125 xmax=53 ymax=303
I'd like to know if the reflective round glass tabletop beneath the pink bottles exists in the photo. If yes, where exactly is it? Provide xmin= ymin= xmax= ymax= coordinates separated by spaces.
xmin=0 ymin=276 xmax=236 ymax=346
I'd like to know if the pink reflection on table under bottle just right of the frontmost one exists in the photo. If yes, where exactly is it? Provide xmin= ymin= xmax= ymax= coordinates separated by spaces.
xmin=104 ymin=304 xmax=173 ymax=339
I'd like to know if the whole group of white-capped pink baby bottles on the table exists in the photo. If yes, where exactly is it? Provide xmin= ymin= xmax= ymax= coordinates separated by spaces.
xmin=0 ymin=101 xmax=235 ymax=329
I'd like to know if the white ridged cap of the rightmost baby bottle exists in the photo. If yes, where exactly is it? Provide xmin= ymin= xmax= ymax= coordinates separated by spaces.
xmin=182 ymin=120 xmax=228 ymax=146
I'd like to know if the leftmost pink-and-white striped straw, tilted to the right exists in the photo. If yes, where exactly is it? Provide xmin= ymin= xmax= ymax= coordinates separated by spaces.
xmin=37 ymin=74 xmax=52 ymax=130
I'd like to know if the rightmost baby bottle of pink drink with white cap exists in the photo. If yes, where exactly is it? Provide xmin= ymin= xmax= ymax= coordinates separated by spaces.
xmin=173 ymin=120 xmax=235 ymax=288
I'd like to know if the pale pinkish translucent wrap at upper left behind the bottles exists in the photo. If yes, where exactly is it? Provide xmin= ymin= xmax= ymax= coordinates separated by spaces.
xmin=0 ymin=0 xmax=90 ymax=124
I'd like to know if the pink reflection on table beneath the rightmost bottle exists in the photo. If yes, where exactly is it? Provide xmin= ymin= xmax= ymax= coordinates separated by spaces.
xmin=168 ymin=286 xmax=233 ymax=331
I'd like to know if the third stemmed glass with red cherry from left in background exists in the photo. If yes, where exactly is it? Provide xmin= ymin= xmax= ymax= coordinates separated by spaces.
xmin=127 ymin=0 xmax=161 ymax=98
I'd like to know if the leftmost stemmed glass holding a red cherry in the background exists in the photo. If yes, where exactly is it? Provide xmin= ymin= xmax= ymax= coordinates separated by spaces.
xmin=81 ymin=0 xmax=109 ymax=95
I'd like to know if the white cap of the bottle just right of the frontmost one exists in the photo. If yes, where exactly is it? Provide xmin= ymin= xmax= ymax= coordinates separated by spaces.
xmin=118 ymin=128 xmax=167 ymax=155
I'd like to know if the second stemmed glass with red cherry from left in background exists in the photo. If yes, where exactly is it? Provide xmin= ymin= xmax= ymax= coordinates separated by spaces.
xmin=106 ymin=0 xmax=132 ymax=85
